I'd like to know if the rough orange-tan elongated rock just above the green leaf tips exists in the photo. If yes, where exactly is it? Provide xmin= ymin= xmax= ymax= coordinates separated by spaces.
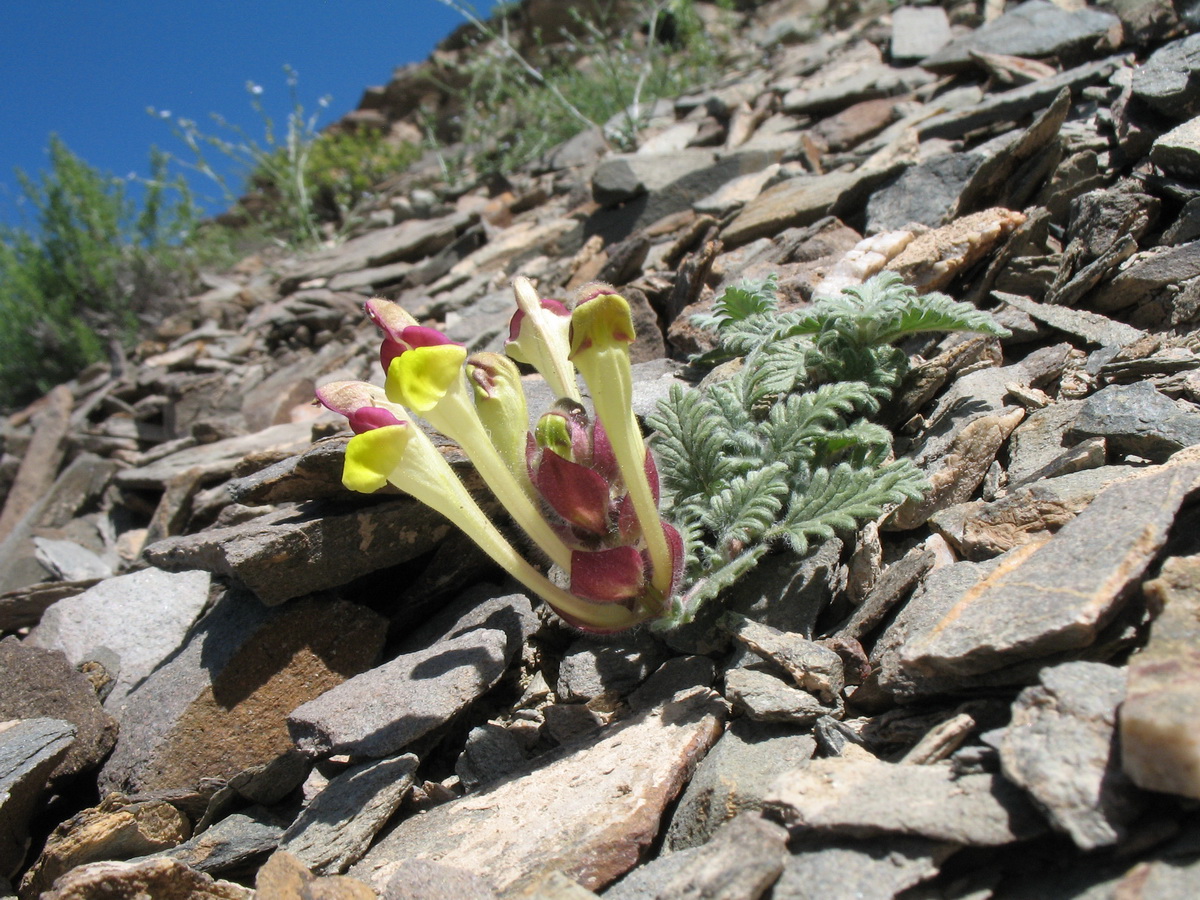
xmin=888 ymin=206 xmax=1025 ymax=292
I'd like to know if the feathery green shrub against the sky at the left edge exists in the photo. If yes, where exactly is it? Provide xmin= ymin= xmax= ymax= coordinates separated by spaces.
xmin=0 ymin=137 xmax=196 ymax=406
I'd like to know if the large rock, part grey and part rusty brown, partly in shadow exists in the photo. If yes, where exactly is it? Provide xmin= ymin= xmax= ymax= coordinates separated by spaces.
xmin=100 ymin=592 xmax=386 ymax=793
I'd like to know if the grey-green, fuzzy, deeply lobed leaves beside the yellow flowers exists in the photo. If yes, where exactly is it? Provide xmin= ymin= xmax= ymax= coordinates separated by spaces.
xmin=648 ymin=272 xmax=1008 ymax=625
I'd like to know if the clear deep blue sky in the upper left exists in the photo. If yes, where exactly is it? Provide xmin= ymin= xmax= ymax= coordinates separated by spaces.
xmin=0 ymin=0 xmax=491 ymax=223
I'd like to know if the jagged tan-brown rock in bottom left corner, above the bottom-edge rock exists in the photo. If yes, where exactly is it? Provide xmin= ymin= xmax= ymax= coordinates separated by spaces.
xmin=20 ymin=793 xmax=192 ymax=896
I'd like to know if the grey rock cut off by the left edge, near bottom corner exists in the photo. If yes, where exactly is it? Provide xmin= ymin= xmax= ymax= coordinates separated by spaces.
xmin=0 ymin=719 xmax=74 ymax=878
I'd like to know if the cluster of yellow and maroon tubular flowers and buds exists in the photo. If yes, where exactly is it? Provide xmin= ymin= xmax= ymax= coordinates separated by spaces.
xmin=317 ymin=278 xmax=683 ymax=631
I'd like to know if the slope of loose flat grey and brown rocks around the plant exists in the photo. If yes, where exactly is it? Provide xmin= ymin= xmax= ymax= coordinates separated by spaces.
xmin=0 ymin=0 xmax=1200 ymax=900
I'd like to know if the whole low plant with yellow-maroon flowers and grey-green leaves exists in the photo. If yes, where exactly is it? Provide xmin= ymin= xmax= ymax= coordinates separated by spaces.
xmin=317 ymin=275 xmax=1003 ymax=632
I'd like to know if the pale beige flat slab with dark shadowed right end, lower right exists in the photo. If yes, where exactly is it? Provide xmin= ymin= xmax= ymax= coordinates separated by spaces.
xmin=766 ymin=757 xmax=1045 ymax=847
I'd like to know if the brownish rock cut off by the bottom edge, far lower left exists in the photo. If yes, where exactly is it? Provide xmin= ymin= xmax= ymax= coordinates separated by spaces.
xmin=41 ymin=859 xmax=252 ymax=900
